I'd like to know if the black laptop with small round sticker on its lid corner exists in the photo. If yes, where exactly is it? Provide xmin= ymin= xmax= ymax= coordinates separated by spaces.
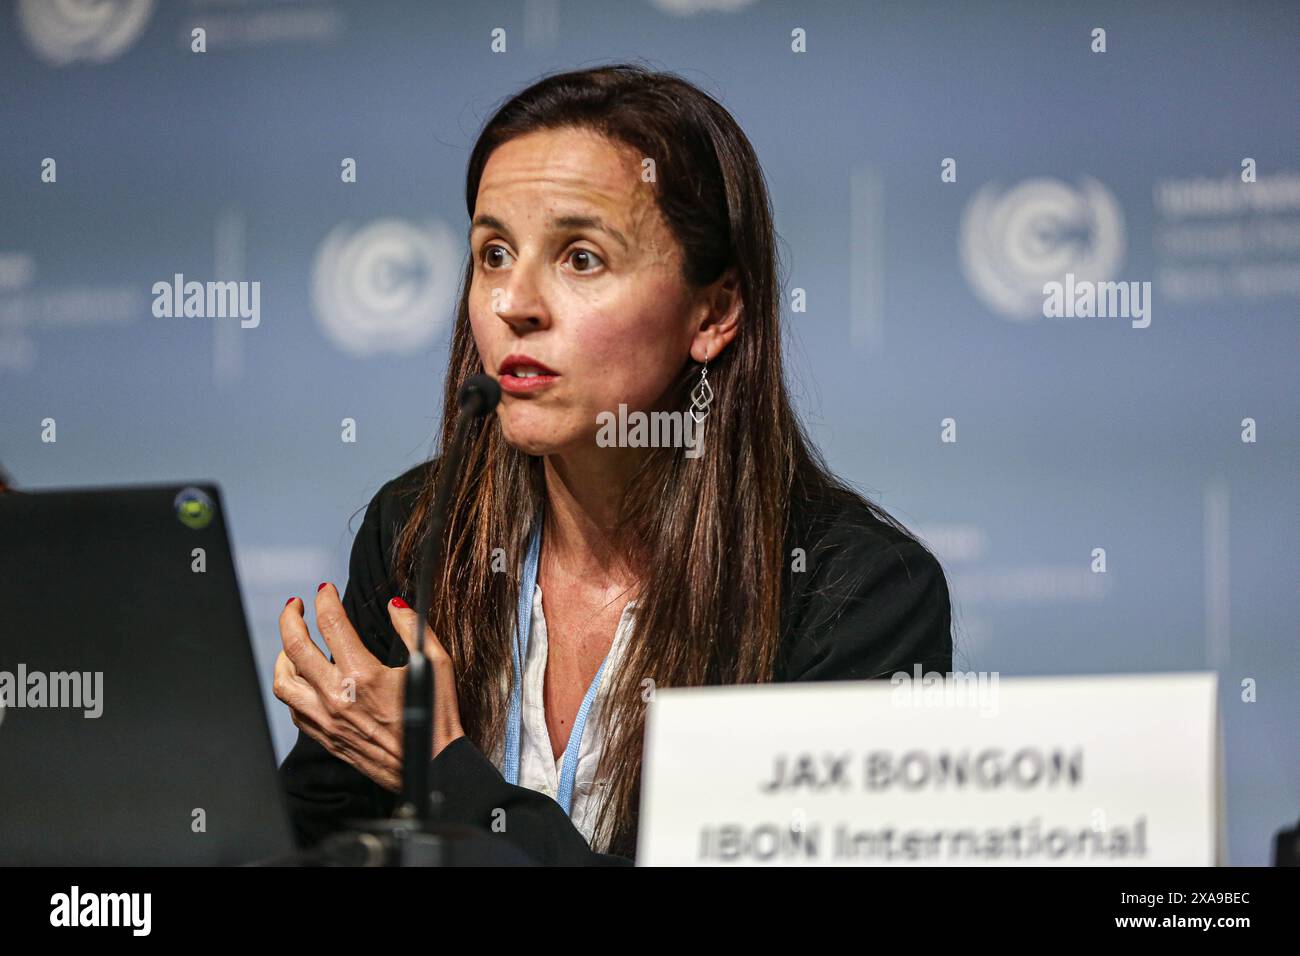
xmin=0 ymin=483 xmax=294 ymax=866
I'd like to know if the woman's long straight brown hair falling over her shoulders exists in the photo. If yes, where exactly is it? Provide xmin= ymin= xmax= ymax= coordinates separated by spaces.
xmin=395 ymin=64 xmax=925 ymax=856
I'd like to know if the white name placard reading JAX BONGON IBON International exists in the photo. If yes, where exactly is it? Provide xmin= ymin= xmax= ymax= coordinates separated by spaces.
xmin=637 ymin=674 xmax=1222 ymax=866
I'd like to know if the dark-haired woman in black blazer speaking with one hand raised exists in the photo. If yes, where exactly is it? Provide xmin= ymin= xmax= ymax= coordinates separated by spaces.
xmin=276 ymin=65 xmax=952 ymax=864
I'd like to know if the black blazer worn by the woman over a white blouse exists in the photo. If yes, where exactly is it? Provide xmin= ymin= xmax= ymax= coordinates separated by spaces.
xmin=280 ymin=463 xmax=953 ymax=865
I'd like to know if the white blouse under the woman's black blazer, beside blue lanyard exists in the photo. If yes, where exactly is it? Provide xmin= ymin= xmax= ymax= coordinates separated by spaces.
xmin=491 ymin=584 xmax=637 ymax=852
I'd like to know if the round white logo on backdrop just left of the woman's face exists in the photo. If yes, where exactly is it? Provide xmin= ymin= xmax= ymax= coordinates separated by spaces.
xmin=312 ymin=219 xmax=458 ymax=356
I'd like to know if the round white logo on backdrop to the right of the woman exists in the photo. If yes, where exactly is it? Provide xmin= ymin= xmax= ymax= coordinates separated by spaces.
xmin=959 ymin=177 xmax=1125 ymax=321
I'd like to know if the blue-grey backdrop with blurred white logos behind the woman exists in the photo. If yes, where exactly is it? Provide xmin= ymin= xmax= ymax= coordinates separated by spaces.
xmin=0 ymin=0 xmax=1300 ymax=864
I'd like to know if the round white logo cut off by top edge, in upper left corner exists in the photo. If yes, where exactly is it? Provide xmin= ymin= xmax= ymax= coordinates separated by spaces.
xmin=18 ymin=0 xmax=153 ymax=66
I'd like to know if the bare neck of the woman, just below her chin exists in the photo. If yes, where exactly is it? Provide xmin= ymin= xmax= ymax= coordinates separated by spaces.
xmin=542 ymin=447 xmax=642 ymax=585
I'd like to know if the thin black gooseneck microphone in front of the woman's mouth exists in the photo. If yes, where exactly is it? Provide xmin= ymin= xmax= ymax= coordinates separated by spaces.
xmin=397 ymin=375 xmax=501 ymax=823
